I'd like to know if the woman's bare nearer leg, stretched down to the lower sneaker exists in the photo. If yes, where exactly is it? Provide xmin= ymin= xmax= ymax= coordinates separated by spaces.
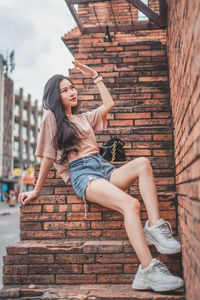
xmin=85 ymin=179 xmax=153 ymax=268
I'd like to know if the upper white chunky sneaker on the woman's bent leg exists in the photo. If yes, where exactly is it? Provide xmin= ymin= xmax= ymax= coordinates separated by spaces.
xmin=143 ymin=219 xmax=181 ymax=254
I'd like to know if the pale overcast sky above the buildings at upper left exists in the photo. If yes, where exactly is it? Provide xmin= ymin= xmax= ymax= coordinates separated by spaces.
xmin=0 ymin=0 xmax=76 ymax=103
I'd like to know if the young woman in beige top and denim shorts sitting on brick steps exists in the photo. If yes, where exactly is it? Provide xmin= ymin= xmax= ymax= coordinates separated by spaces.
xmin=19 ymin=61 xmax=183 ymax=291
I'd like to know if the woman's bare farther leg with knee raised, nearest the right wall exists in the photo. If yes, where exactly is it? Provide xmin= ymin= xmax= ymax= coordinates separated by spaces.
xmin=110 ymin=157 xmax=160 ymax=226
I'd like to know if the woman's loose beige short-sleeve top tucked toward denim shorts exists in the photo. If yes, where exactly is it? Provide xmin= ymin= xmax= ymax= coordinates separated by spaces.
xmin=35 ymin=107 xmax=107 ymax=183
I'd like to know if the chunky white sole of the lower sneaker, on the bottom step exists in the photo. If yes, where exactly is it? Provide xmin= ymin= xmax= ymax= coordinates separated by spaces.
xmin=132 ymin=280 xmax=184 ymax=292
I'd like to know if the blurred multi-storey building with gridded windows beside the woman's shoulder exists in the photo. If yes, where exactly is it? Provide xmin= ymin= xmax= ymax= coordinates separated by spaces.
xmin=13 ymin=88 xmax=42 ymax=189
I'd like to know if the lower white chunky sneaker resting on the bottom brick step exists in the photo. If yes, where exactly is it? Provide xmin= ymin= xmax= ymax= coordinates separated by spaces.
xmin=132 ymin=258 xmax=184 ymax=292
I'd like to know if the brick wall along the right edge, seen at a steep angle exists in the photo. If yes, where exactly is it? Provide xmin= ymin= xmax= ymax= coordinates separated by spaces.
xmin=168 ymin=0 xmax=200 ymax=300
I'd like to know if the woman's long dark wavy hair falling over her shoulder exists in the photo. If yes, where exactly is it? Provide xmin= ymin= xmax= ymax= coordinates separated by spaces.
xmin=43 ymin=74 xmax=84 ymax=163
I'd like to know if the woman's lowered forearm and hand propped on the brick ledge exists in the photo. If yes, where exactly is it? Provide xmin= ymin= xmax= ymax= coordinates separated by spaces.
xmin=18 ymin=157 xmax=54 ymax=205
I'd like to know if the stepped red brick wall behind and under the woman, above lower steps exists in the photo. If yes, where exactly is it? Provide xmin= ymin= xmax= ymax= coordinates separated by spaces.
xmin=21 ymin=36 xmax=176 ymax=240
